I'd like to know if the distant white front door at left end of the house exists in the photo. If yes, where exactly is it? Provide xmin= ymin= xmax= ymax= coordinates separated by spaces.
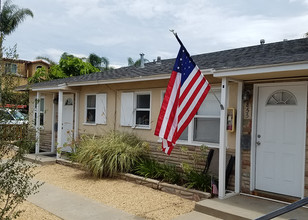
xmin=61 ymin=94 xmax=74 ymax=152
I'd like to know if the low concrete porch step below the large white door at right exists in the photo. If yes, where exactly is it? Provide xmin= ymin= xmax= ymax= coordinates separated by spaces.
xmin=195 ymin=195 xmax=308 ymax=220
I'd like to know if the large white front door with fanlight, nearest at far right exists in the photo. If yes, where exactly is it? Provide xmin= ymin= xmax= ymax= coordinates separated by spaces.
xmin=256 ymin=83 xmax=307 ymax=197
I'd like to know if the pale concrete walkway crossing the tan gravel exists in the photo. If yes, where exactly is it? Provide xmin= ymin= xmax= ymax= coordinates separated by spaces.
xmin=27 ymin=183 xmax=143 ymax=220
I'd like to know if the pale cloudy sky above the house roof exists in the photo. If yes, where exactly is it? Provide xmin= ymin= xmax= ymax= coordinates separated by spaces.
xmin=2 ymin=0 xmax=308 ymax=67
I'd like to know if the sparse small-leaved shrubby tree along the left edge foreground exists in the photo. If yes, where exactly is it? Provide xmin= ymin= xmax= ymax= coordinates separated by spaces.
xmin=0 ymin=43 xmax=41 ymax=220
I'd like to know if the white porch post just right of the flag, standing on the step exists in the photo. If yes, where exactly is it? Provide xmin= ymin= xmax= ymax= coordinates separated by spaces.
xmin=218 ymin=77 xmax=229 ymax=199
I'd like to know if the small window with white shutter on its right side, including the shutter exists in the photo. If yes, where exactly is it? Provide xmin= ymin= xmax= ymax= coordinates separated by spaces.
xmin=85 ymin=93 xmax=107 ymax=124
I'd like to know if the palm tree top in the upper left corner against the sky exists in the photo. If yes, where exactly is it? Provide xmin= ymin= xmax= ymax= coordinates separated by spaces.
xmin=0 ymin=0 xmax=33 ymax=58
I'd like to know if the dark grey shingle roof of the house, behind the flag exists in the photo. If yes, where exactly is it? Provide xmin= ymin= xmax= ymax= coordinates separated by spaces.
xmin=24 ymin=38 xmax=308 ymax=88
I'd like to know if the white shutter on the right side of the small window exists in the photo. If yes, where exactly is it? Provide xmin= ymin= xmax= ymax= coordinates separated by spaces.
xmin=95 ymin=93 xmax=107 ymax=124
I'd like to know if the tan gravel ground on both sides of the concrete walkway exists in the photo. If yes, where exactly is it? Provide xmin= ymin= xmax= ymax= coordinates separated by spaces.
xmin=20 ymin=164 xmax=194 ymax=220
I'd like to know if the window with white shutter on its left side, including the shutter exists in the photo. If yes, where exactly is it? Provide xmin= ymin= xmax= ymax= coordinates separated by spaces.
xmin=121 ymin=92 xmax=151 ymax=128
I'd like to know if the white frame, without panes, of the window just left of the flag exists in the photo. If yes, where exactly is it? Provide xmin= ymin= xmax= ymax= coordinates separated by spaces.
xmin=132 ymin=91 xmax=152 ymax=129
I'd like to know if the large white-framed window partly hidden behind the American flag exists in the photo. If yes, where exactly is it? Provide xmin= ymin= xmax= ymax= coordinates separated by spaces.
xmin=179 ymin=88 xmax=221 ymax=143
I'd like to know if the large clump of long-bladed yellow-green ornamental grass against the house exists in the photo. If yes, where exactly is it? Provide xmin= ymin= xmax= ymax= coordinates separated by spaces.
xmin=76 ymin=132 xmax=148 ymax=177
